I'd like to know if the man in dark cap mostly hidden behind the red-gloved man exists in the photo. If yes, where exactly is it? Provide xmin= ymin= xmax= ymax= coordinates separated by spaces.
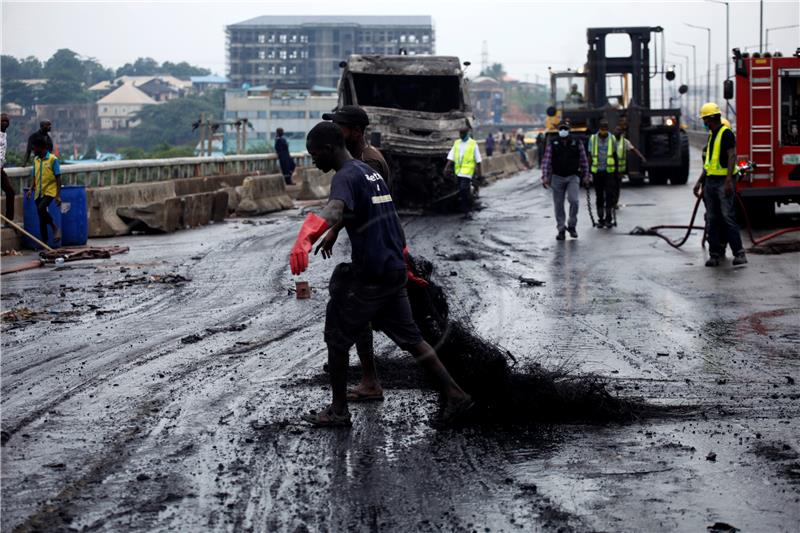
xmin=314 ymin=105 xmax=391 ymax=402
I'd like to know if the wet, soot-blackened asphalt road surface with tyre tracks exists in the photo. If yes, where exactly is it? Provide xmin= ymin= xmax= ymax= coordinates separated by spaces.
xmin=0 ymin=153 xmax=800 ymax=532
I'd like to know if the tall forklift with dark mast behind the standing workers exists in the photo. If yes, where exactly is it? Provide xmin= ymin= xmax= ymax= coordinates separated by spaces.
xmin=546 ymin=26 xmax=689 ymax=185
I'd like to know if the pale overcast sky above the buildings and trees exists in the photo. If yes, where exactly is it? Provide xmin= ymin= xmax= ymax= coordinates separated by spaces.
xmin=2 ymin=0 xmax=800 ymax=81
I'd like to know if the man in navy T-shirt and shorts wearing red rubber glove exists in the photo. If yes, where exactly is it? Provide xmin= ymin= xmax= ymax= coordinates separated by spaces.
xmin=289 ymin=122 xmax=473 ymax=426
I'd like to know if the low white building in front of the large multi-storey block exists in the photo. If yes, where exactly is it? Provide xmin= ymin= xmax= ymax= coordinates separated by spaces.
xmin=225 ymin=85 xmax=337 ymax=153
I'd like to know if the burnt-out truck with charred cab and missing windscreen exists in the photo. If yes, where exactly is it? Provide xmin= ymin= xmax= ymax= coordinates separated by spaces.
xmin=338 ymin=55 xmax=473 ymax=211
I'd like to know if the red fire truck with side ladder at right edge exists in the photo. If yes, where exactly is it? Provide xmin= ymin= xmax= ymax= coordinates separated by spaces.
xmin=724 ymin=48 xmax=800 ymax=225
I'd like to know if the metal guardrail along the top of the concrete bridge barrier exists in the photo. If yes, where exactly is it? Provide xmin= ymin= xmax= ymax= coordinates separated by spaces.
xmin=5 ymin=152 xmax=311 ymax=191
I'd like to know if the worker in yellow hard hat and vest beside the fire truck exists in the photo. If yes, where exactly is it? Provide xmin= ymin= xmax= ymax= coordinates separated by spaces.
xmin=694 ymin=102 xmax=747 ymax=267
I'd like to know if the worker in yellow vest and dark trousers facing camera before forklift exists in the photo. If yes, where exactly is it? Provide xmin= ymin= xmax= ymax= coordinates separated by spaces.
xmin=589 ymin=119 xmax=618 ymax=228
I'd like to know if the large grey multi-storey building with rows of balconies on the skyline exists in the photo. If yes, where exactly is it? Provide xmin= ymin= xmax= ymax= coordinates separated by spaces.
xmin=226 ymin=16 xmax=435 ymax=88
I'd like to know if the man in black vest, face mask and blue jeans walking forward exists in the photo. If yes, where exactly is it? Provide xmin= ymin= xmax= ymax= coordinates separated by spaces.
xmin=542 ymin=120 xmax=589 ymax=241
